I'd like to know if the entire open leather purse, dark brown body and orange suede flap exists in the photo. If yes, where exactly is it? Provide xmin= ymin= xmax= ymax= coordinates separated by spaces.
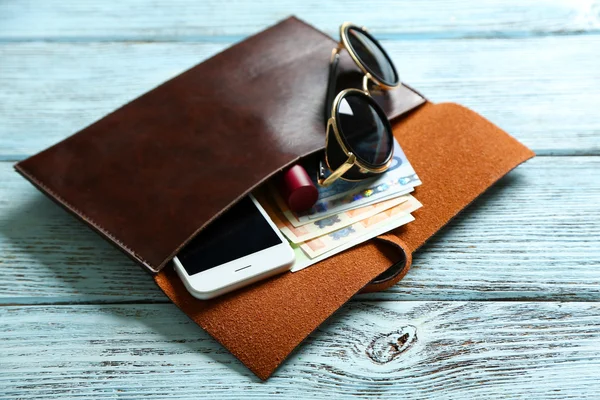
xmin=15 ymin=17 xmax=534 ymax=379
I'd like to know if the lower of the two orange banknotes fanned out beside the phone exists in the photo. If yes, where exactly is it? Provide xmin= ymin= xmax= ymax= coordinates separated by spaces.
xmin=300 ymin=196 xmax=422 ymax=258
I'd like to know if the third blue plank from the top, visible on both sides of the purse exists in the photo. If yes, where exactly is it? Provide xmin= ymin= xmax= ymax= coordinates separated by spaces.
xmin=0 ymin=157 xmax=600 ymax=304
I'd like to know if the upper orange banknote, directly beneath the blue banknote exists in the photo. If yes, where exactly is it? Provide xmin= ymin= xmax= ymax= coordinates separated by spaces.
xmin=255 ymin=192 xmax=412 ymax=243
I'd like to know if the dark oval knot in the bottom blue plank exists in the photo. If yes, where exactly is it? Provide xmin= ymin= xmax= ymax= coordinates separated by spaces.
xmin=365 ymin=325 xmax=417 ymax=364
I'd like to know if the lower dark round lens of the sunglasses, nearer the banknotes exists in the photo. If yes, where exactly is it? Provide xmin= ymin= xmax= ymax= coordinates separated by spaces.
xmin=336 ymin=92 xmax=394 ymax=167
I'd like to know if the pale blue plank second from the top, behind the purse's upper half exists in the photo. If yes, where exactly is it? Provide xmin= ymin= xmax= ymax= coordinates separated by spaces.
xmin=0 ymin=36 xmax=600 ymax=160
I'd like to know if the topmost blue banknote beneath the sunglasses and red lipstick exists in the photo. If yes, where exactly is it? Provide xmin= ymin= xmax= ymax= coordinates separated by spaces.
xmin=277 ymin=140 xmax=421 ymax=227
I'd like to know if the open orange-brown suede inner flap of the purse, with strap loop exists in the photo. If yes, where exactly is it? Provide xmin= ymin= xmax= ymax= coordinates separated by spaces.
xmin=155 ymin=104 xmax=534 ymax=379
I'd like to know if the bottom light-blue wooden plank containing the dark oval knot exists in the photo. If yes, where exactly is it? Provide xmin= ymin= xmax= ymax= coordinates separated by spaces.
xmin=0 ymin=301 xmax=600 ymax=400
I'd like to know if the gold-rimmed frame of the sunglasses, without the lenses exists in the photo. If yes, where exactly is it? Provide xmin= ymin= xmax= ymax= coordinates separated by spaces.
xmin=317 ymin=22 xmax=401 ymax=187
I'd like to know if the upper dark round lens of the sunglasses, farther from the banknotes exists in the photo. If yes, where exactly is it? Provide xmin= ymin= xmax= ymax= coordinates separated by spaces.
xmin=347 ymin=27 xmax=399 ymax=86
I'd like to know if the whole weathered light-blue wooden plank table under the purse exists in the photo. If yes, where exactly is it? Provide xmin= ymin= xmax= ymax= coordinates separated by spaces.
xmin=0 ymin=0 xmax=600 ymax=399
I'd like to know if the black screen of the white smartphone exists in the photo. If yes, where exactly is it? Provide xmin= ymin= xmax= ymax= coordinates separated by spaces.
xmin=177 ymin=197 xmax=281 ymax=275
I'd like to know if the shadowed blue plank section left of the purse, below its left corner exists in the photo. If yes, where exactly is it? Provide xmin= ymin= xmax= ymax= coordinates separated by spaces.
xmin=0 ymin=162 xmax=159 ymax=304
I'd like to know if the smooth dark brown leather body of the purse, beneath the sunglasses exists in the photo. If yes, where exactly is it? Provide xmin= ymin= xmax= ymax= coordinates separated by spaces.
xmin=16 ymin=18 xmax=424 ymax=272
